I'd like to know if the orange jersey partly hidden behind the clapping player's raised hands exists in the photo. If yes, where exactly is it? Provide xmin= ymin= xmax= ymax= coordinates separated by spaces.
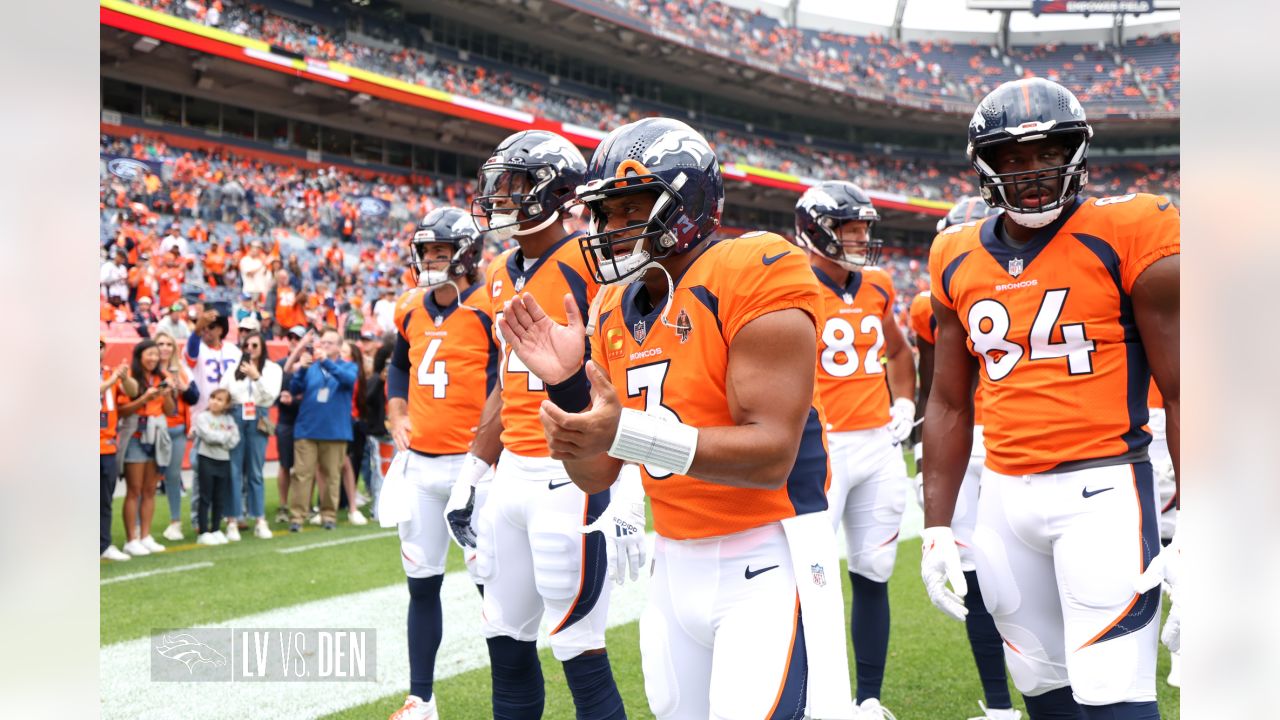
xmin=486 ymin=233 xmax=599 ymax=457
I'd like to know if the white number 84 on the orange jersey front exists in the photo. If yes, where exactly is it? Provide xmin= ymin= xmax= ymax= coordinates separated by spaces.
xmin=969 ymin=288 xmax=1094 ymax=382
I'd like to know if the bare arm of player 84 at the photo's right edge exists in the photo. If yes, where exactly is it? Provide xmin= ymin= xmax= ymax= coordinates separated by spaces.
xmin=1132 ymin=255 xmax=1181 ymax=491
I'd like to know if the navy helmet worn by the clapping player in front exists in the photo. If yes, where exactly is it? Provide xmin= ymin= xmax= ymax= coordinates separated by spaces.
xmin=577 ymin=118 xmax=724 ymax=284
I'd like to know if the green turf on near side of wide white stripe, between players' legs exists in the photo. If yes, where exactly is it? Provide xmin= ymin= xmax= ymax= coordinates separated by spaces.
xmin=314 ymin=539 xmax=1179 ymax=720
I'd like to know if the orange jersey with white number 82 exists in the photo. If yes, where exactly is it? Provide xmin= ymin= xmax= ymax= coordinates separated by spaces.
xmin=813 ymin=268 xmax=895 ymax=433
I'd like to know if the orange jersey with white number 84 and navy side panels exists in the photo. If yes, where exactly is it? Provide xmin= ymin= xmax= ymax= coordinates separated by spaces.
xmin=929 ymin=193 xmax=1180 ymax=475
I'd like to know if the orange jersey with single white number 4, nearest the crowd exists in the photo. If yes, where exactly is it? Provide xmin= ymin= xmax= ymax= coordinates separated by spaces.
xmin=396 ymin=284 xmax=498 ymax=455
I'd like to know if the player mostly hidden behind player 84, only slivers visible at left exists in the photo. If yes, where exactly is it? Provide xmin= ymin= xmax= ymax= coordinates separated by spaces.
xmin=909 ymin=197 xmax=1023 ymax=720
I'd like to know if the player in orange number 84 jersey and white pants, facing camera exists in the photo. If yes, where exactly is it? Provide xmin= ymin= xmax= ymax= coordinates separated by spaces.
xmin=922 ymin=78 xmax=1180 ymax=720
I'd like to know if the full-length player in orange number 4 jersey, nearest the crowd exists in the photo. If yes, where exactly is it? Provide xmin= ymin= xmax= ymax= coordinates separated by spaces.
xmin=387 ymin=208 xmax=498 ymax=720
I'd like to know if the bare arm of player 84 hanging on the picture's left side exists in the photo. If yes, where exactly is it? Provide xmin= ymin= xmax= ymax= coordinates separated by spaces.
xmin=924 ymin=300 xmax=977 ymax=528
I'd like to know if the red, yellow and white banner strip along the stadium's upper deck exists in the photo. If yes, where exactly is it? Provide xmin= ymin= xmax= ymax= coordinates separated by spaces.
xmin=100 ymin=0 xmax=951 ymax=217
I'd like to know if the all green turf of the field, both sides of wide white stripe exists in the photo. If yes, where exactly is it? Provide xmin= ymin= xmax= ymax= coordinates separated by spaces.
xmin=100 ymin=466 xmax=1179 ymax=720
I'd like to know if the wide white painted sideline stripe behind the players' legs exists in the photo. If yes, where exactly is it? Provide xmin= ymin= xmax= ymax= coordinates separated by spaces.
xmin=99 ymin=501 xmax=923 ymax=720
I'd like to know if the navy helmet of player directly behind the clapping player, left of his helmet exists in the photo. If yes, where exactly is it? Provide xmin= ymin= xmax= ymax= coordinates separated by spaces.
xmin=471 ymin=129 xmax=586 ymax=241
